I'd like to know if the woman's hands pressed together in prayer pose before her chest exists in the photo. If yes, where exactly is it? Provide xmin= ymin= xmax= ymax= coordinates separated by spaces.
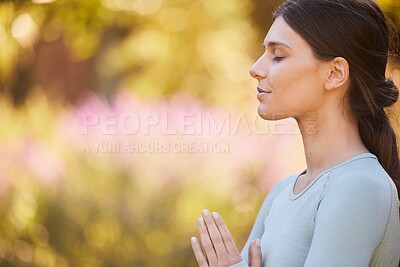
xmin=191 ymin=210 xmax=262 ymax=267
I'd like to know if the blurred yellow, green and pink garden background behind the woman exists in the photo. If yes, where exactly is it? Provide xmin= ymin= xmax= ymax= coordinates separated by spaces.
xmin=0 ymin=0 xmax=400 ymax=267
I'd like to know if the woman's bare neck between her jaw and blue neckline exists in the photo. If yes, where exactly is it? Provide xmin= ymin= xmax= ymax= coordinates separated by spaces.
xmin=296 ymin=106 xmax=368 ymax=179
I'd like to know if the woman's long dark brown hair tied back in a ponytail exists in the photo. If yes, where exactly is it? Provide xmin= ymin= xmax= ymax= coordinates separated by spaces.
xmin=274 ymin=0 xmax=400 ymax=198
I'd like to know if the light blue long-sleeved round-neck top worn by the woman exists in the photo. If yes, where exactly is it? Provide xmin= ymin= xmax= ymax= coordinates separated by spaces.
xmin=232 ymin=153 xmax=400 ymax=267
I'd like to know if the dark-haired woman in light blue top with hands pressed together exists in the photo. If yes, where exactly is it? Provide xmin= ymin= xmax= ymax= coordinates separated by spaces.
xmin=192 ymin=0 xmax=400 ymax=267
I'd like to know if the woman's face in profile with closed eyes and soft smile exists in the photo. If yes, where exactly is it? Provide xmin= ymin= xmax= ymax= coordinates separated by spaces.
xmin=250 ymin=17 xmax=324 ymax=120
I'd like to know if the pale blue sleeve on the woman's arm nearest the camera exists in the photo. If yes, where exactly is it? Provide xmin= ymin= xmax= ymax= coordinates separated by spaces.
xmin=304 ymin=172 xmax=391 ymax=267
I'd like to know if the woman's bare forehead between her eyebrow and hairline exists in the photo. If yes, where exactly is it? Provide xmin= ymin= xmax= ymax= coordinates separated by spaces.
xmin=264 ymin=17 xmax=311 ymax=51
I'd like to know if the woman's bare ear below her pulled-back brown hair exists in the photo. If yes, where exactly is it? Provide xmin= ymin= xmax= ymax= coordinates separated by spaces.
xmin=325 ymin=57 xmax=350 ymax=90
